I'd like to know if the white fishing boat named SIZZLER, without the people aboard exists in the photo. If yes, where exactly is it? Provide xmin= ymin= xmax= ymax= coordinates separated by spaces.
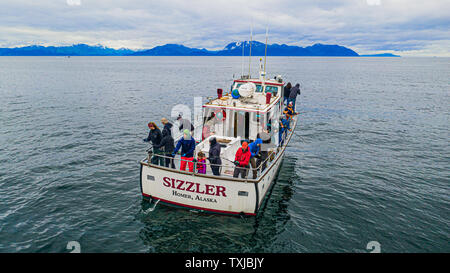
xmin=140 ymin=59 xmax=298 ymax=216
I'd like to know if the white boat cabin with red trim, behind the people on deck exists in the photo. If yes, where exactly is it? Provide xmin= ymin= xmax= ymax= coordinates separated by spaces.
xmin=202 ymin=76 xmax=283 ymax=145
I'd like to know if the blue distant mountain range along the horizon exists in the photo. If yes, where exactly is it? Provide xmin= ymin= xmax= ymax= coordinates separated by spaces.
xmin=0 ymin=41 xmax=398 ymax=57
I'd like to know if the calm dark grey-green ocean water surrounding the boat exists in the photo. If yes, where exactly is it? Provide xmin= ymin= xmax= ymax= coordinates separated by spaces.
xmin=0 ymin=57 xmax=450 ymax=252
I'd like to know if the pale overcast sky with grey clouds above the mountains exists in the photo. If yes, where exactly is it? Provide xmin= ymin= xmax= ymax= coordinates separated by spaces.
xmin=0 ymin=0 xmax=450 ymax=56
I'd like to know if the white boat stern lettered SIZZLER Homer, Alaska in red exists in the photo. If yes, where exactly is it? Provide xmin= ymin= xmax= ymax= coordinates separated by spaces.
xmin=141 ymin=161 xmax=259 ymax=215
